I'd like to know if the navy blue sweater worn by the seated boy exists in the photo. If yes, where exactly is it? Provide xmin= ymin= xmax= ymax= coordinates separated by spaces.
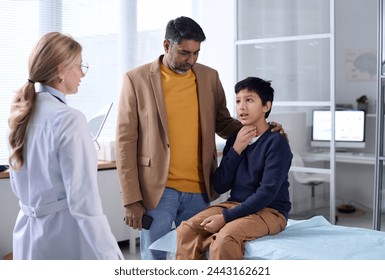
xmin=213 ymin=129 xmax=293 ymax=222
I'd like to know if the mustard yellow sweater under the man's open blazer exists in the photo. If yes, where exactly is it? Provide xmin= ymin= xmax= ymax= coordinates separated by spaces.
xmin=161 ymin=65 xmax=206 ymax=193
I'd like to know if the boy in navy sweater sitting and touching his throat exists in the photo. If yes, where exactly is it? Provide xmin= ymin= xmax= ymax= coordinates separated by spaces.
xmin=176 ymin=77 xmax=293 ymax=260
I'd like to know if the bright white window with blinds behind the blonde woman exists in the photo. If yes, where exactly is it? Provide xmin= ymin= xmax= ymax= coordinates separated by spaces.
xmin=0 ymin=0 xmax=192 ymax=164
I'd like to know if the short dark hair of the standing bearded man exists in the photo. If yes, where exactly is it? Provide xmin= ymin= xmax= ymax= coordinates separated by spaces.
xmin=165 ymin=16 xmax=206 ymax=44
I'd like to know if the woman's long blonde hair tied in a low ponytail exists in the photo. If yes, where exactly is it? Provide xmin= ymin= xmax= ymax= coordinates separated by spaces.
xmin=8 ymin=32 xmax=82 ymax=170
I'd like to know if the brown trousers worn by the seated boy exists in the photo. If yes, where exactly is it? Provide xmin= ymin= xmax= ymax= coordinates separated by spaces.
xmin=176 ymin=202 xmax=287 ymax=260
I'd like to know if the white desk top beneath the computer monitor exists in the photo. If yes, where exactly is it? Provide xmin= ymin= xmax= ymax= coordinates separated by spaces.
xmin=302 ymin=151 xmax=375 ymax=164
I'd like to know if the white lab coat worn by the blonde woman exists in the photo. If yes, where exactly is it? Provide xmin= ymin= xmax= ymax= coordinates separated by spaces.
xmin=11 ymin=90 xmax=123 ymax=260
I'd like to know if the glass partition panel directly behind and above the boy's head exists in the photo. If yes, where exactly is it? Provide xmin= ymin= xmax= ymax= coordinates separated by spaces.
xmin=237 ymin=39 xmax=330 ymax=101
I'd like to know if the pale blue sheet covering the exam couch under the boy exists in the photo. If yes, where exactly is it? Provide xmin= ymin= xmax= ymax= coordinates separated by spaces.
xmin=150 ymin=216 xmax=385 ymax=260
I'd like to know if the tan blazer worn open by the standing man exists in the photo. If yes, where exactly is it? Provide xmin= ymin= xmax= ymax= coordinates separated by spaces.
xmin=116 ymin=56 xmax=241 ymax=209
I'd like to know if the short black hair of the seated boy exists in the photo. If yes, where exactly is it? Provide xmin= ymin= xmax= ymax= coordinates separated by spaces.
xmin=234 ymin=77 xmax=274 ymax=118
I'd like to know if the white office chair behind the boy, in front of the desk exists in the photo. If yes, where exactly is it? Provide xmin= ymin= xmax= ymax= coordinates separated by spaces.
xmin=292 ymin=151 xmax=330 ymax=217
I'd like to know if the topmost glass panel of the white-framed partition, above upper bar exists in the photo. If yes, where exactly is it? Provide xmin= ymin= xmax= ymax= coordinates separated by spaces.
xmin=238 ymin=0 xmax=330 ymax=40
